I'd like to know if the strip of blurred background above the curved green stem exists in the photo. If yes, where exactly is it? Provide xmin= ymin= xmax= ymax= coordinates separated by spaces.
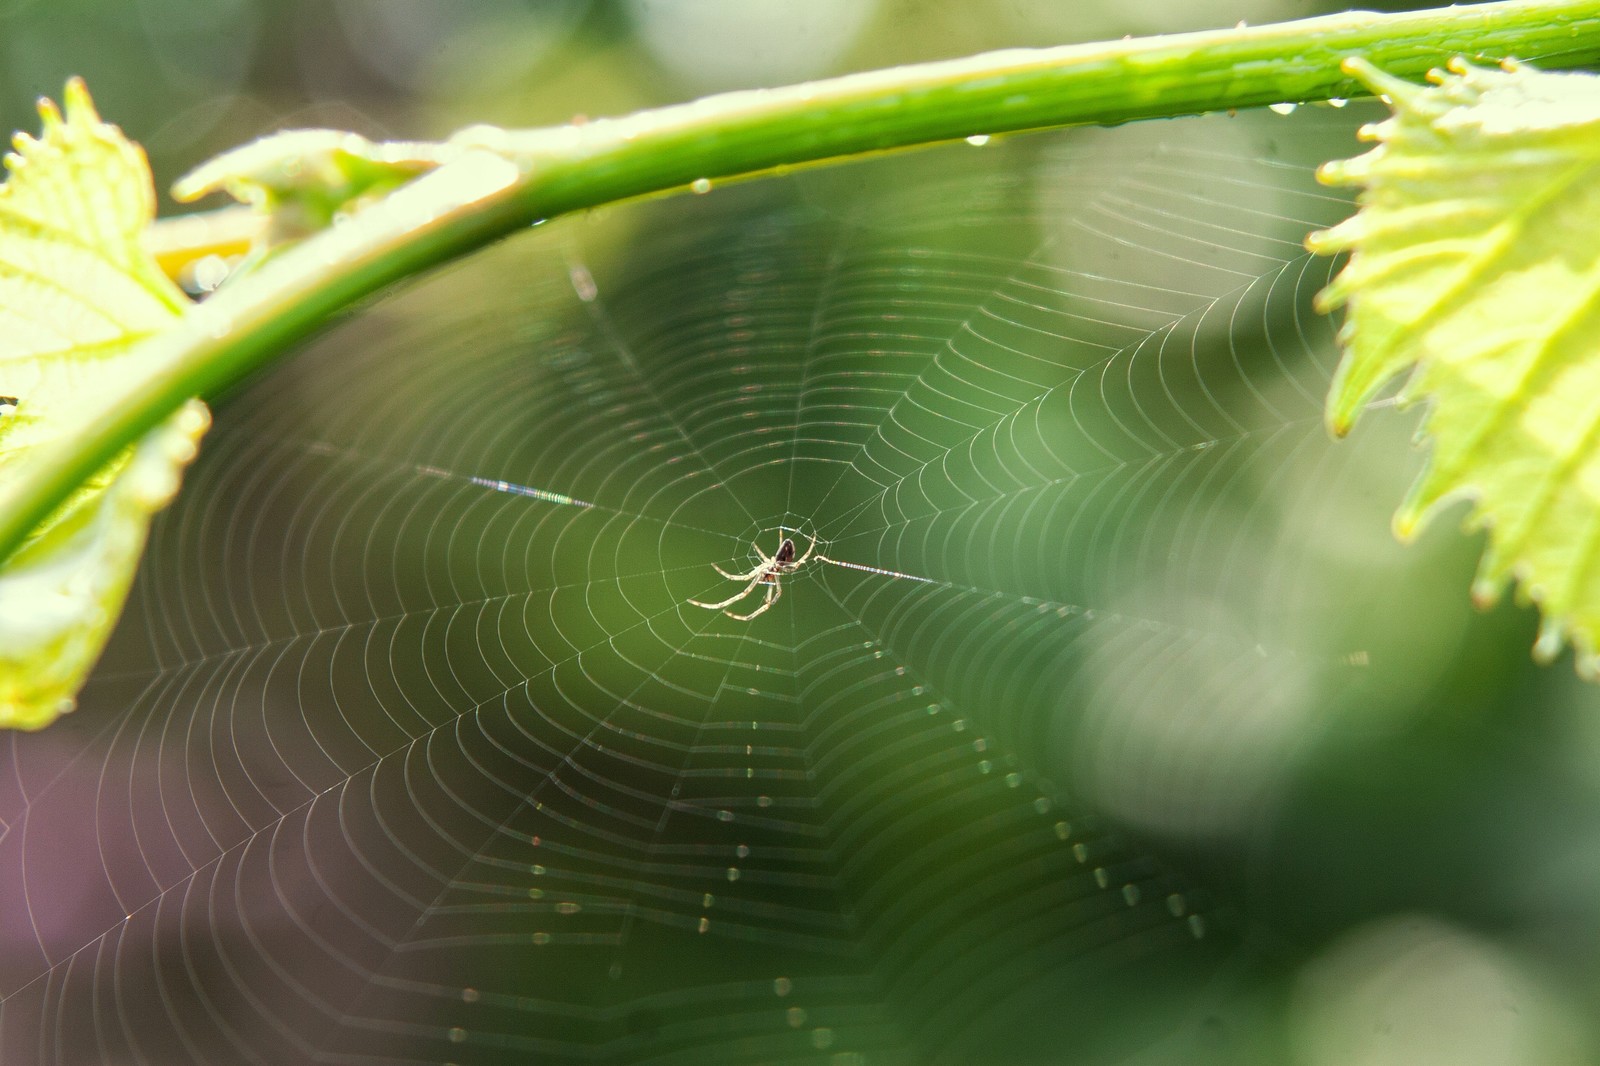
xmin=0 ymin=0 xmax=1446 ymax=187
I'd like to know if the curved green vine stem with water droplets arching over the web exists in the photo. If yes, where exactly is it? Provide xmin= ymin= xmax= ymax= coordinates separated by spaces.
xmin=0 ymin=0 xmax=1600 ymax=562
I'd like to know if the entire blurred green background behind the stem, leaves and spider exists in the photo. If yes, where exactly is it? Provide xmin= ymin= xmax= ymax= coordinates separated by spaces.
xmin=9 ymin=0 xmax=1600 ymax=1066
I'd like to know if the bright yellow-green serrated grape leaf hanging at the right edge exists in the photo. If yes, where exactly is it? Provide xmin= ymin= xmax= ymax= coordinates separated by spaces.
xmin=1307 ymin=59 xmax=1600 ymax=677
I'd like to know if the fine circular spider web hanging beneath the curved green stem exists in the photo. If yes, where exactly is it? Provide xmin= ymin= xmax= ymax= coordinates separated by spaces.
xmin=0 ymin=109 xmax=1414 ymax=1066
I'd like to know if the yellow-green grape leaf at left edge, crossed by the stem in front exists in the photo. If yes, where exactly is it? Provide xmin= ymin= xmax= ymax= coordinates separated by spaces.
xmin=0 ymin=80 xmax=208 ymax=728
